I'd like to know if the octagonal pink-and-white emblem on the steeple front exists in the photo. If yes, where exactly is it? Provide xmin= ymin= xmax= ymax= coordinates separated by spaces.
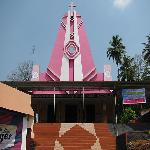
xmin=64 ymin=41 xmax=79 ymax=59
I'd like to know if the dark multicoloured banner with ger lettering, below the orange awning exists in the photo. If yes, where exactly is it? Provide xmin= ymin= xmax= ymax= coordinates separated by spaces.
xmin=0 ymin=109 xmax=23 ymax=150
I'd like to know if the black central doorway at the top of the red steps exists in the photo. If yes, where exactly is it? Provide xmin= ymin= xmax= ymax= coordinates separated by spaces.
xmin=65 ymin=104 xmax=78 ymax=123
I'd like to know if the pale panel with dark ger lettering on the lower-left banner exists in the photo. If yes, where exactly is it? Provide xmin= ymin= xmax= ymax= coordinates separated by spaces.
xmin=0 ymin=124 xmax=17 ymax=149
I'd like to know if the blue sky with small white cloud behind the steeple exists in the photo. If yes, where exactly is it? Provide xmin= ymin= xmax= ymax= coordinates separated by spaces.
xmin=0 ymin=0 xmax=150 ymax=81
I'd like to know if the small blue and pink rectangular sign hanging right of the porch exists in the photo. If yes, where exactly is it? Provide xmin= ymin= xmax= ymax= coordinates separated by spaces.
xmin=122 ymin=88 xmax=146 ymax=104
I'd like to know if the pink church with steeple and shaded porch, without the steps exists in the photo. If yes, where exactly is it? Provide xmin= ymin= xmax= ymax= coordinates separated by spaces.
xmin=32 ymin=3 xmax=114 ymax=122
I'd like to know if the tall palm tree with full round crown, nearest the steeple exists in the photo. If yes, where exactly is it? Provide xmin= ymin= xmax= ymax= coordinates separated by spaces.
xmin=107 ymin=35 xmax=126 ymax=79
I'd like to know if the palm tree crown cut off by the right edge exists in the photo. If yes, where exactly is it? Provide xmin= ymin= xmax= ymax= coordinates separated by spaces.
xmin=142 ymin=34 xmax=150 ymax=64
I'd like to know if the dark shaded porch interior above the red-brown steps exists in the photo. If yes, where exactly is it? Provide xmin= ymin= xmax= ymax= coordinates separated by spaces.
xmin=32 ymin=95 xmax=115 ymax=123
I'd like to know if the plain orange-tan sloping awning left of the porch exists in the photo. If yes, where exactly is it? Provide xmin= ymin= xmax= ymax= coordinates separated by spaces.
xmin=0 ymin=83 xmax=34 ymax=116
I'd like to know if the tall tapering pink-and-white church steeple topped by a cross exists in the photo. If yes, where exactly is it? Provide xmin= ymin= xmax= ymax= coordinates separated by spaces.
xmin=37 ymin=2 xmax=109 ymax=81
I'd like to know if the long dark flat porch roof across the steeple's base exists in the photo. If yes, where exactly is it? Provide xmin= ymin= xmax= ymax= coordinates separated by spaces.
xmin=1 ymin=81 xmax=150 ymax=92
